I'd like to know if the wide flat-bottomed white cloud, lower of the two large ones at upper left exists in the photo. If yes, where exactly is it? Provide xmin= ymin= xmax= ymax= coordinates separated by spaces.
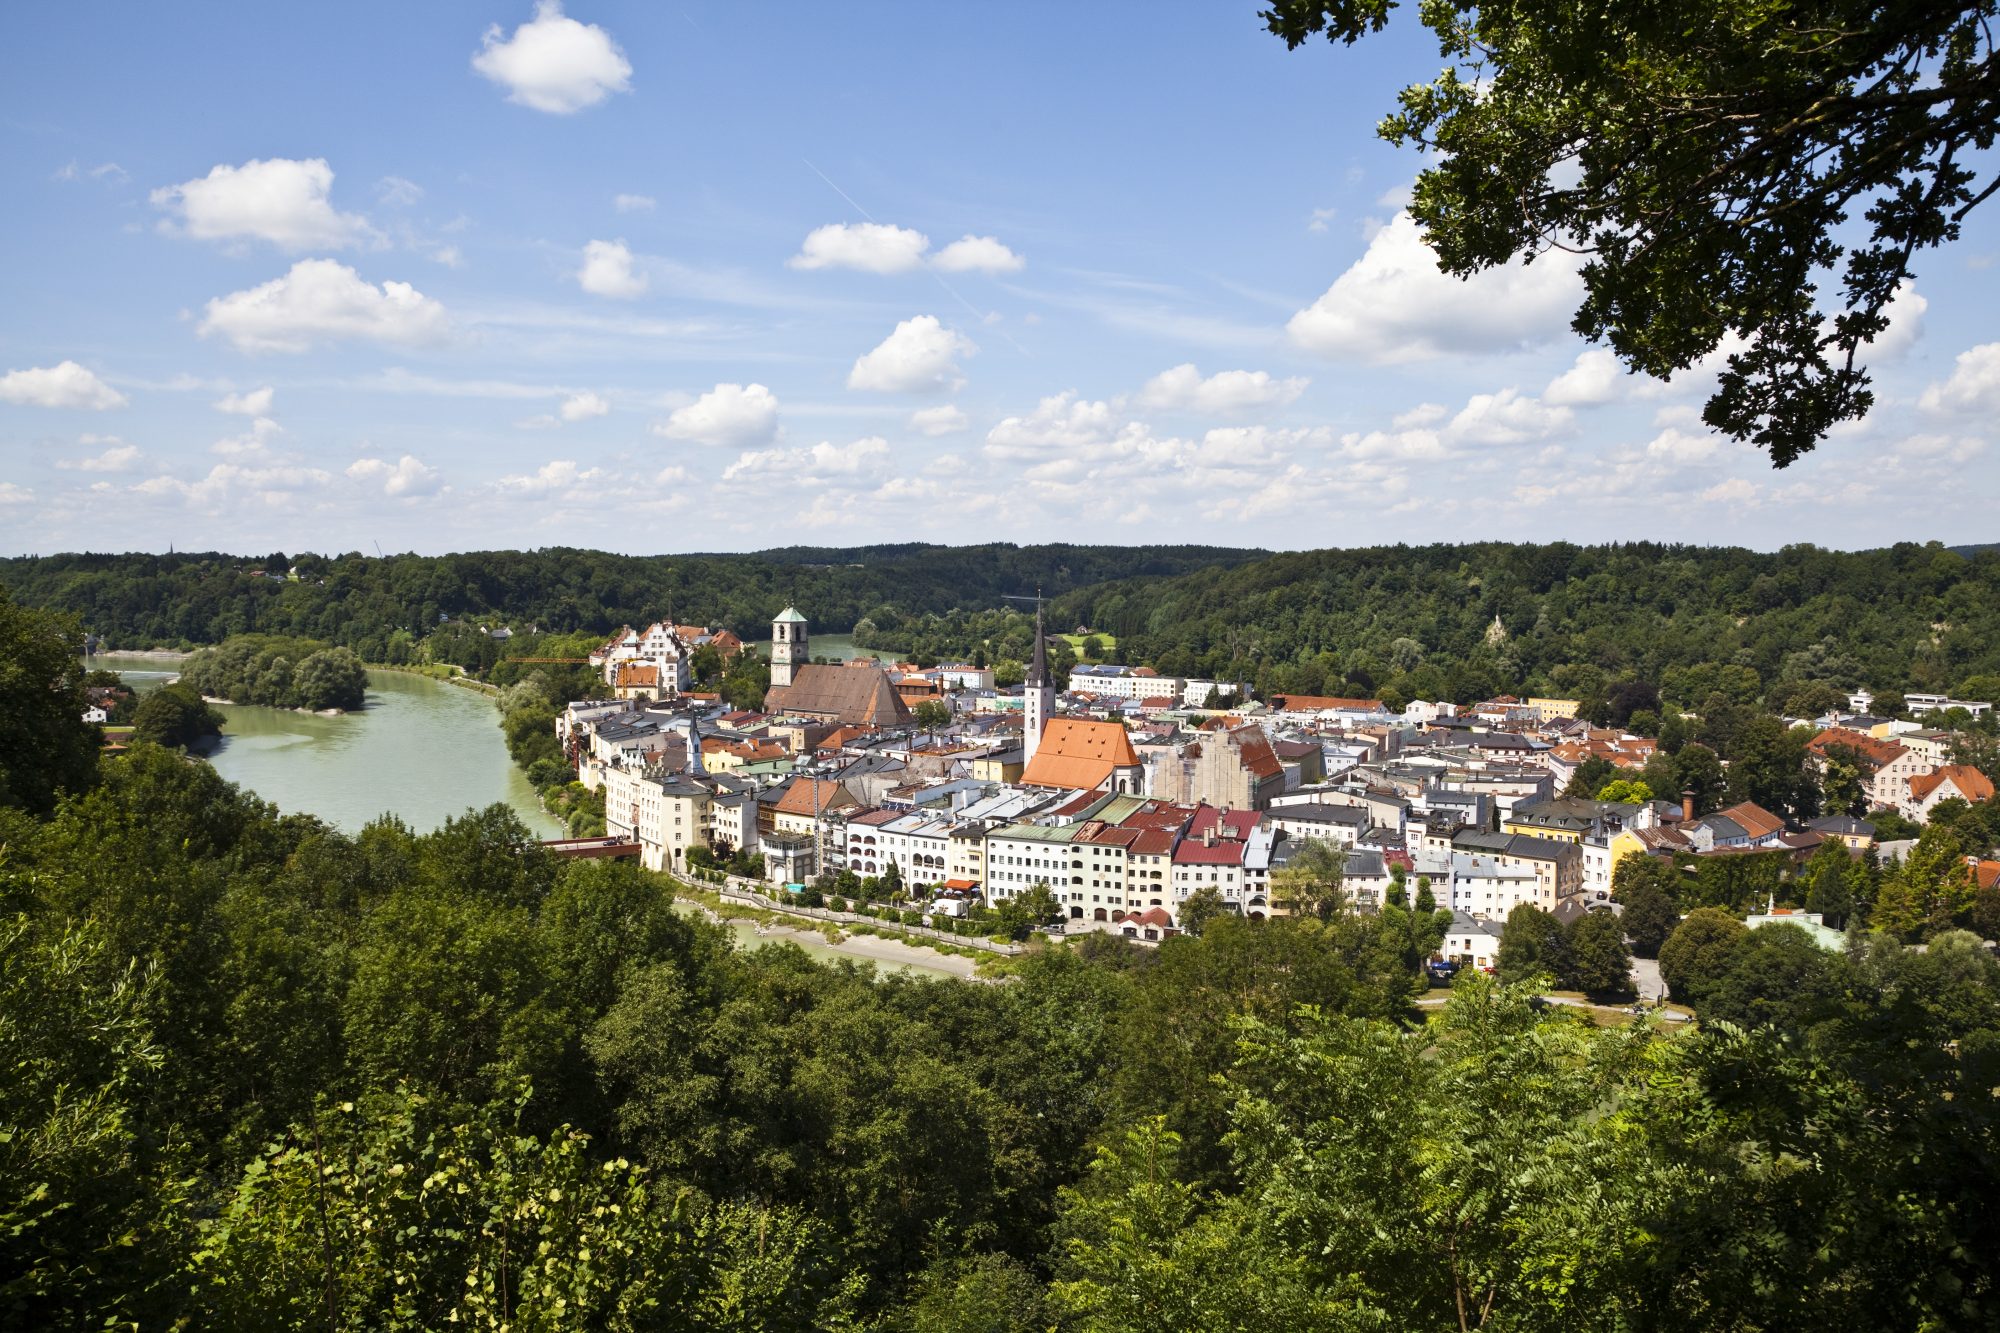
xmin=200 ymin=260 xmax=448 ymax=352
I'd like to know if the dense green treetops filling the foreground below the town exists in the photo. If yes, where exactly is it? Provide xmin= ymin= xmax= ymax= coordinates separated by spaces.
xmin=0 ymin=596 xmax=2000 ymax=1333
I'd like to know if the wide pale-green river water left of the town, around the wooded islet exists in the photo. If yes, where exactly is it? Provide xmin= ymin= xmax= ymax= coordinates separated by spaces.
xmin=86 ymin=656 xmax=562 ymax=839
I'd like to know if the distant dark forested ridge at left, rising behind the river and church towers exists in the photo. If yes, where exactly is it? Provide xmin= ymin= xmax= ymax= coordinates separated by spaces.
xmin=0 ymin=544 xmax=1266 ymax=646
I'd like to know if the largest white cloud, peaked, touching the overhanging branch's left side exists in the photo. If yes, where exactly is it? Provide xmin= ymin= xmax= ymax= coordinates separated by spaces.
xmin=1286 ymin=212 xmax=1582 ymax=364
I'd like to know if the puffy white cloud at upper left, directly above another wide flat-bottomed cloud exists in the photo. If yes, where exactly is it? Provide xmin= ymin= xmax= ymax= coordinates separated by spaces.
xmin=152 ymin=158 xmax=374 ymax=252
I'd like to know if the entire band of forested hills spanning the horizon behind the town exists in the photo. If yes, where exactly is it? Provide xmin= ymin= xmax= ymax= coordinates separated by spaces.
xmin=15 ymin=542 xmax=2000 ymax=711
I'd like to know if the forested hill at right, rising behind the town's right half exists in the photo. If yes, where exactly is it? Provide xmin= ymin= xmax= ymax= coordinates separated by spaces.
xmin=1056 ymin=542 xmax=2000 ymax=707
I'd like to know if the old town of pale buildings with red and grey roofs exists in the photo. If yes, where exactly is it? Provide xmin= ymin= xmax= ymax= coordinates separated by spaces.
xmin=556 ymin=606 xmax=2000 ymax=969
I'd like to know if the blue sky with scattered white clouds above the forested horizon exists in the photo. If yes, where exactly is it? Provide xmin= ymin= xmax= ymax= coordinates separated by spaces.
xmin=0 ymin=0 xmax=2000 ymax=552
